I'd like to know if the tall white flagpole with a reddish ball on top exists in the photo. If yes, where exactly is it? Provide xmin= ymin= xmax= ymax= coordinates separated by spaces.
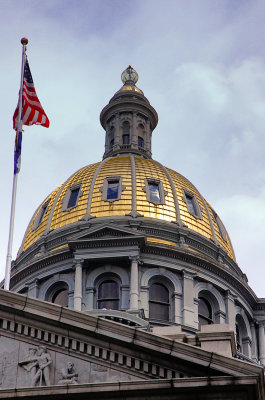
xmin=4 ymin=38 xmax=28 ymax=290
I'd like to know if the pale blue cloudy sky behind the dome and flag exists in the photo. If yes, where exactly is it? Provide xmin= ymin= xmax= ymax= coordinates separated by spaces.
xmin=0 ymin=0 xmax=265 ymax=297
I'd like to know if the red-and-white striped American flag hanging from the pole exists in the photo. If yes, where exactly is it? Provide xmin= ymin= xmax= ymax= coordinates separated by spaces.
xmin=13 ymin=58 xmax=50 ymax=130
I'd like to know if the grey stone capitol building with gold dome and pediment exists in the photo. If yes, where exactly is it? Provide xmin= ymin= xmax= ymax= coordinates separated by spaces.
xmin=0 ymin=66 xmax=265 ymax=400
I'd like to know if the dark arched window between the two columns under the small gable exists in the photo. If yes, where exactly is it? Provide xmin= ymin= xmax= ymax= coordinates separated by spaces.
xmin=97 ymin=279 xmax=120 ymax=310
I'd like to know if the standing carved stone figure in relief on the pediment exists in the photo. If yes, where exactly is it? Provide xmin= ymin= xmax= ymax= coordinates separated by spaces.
xmin=18 ymin=346 xmax=52 ymax=386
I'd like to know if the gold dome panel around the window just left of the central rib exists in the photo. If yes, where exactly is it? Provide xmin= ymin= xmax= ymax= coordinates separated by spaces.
xmin=90 ymin=157 xmax=132 ymax=217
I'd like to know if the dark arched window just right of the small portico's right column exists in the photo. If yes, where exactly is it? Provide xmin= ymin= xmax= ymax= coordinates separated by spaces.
xmin=149 ymin=283 xmax=169 ymax=321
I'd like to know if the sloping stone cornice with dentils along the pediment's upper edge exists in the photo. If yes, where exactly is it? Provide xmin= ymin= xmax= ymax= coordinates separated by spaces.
xmin=0 ymin=290 xmax=263 ymax=379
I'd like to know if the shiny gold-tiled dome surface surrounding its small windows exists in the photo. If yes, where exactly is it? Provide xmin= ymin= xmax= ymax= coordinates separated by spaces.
xmin=21 ymin=154 xmax=235 ymax=260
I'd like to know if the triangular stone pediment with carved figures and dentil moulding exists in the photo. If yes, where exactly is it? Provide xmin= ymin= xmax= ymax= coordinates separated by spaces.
xmin=0 ymin=290 xmax=261 ymax=389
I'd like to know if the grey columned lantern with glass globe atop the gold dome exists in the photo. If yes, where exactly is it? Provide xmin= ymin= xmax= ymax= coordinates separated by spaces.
xmin=100 ymin=65 xmax=158 ymax=158
